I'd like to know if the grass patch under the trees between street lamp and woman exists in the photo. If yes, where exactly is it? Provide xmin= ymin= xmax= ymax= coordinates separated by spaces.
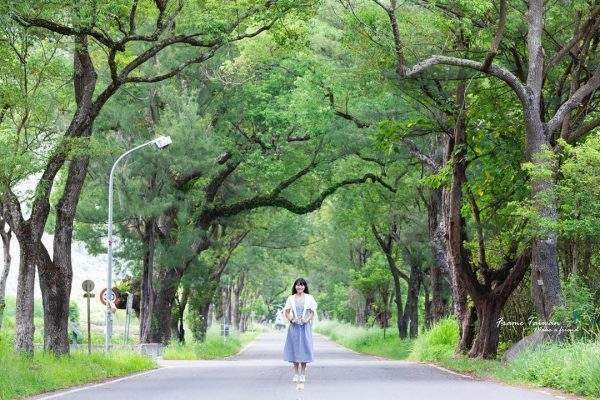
xmin=163 ymin=326 xmax=260 ymax=360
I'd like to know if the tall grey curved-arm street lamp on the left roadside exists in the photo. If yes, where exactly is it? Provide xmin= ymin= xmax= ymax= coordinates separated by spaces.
xmin=104 ymin=136 xmax=172 ymax=352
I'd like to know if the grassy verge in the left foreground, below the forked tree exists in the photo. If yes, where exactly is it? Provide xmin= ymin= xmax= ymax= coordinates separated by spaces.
xmin=0 ymin=334 xmax=156 ymax=400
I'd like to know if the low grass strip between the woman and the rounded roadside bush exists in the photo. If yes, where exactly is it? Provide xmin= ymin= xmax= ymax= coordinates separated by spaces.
xmin=315 ymin=320 xmax=412 ymax=360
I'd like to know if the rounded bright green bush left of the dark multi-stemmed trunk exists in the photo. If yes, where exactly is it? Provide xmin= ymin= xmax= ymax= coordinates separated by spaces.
xmin=410 ymin=317 xmax=459 ymax=361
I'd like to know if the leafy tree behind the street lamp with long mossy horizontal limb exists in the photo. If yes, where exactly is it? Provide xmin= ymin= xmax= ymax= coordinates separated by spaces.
xmin=72 ymin=25 xmax=394 ymax=342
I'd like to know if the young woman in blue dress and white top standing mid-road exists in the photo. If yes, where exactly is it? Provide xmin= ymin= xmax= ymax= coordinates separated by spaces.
xmin=283 ymin=278 xmax=317 ymax=382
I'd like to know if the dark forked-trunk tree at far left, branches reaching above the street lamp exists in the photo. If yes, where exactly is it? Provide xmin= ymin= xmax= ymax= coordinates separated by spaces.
xmin=3 ymin=0 xmax=310 ymax=353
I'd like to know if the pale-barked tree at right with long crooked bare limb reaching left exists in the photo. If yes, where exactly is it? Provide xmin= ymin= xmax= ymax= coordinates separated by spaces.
xmin=374 ymin=0 xmax=600 ymax=321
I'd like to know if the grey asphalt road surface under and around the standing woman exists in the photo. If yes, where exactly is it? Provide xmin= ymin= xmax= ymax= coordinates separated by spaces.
xmin=35 ymin=333 xmax=559 ymax=400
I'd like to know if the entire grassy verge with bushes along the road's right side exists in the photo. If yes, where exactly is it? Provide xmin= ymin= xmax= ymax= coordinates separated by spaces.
xmin=315 ymin=319 xmax=600 ymax=398
